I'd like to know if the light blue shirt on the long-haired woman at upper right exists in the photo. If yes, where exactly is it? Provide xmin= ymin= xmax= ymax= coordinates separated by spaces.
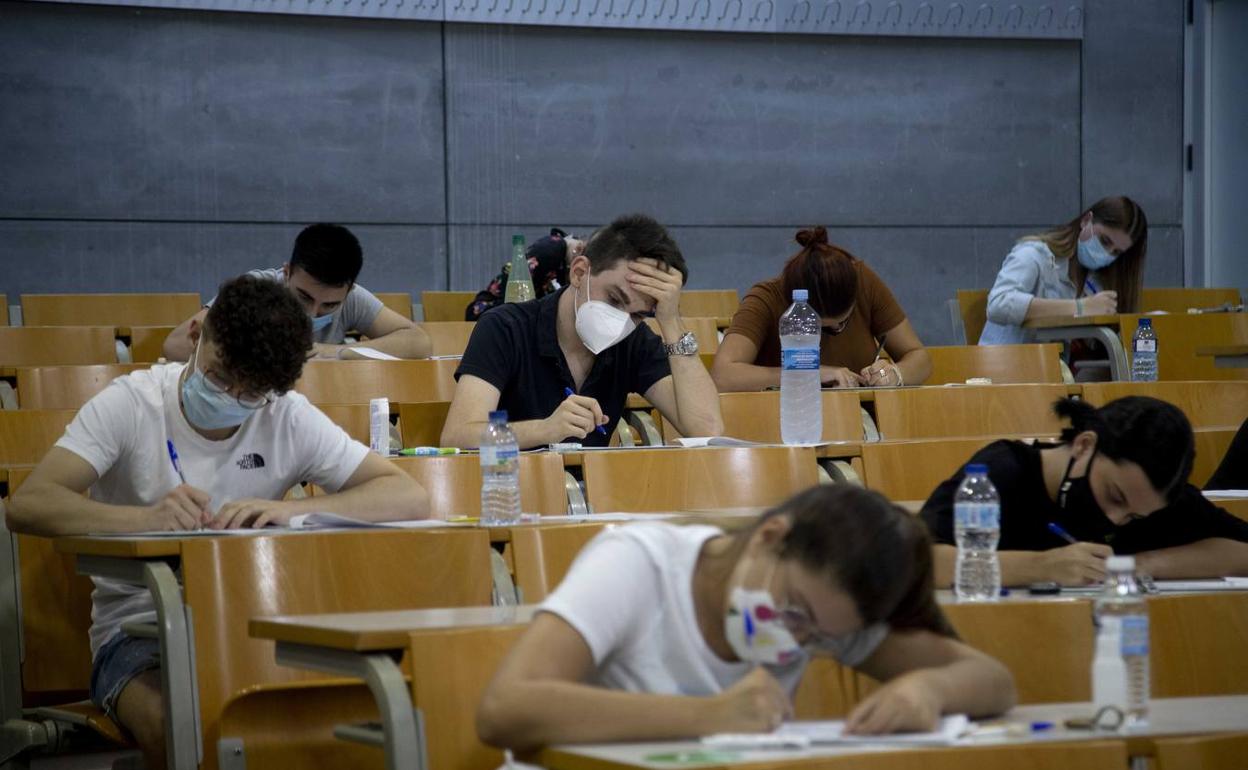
xmin=980 ymin=241 xmax=1076 ymax=344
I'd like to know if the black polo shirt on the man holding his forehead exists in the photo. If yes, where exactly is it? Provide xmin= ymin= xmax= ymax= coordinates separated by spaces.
xmin=456 ymin=288 xmax=671 ymax=447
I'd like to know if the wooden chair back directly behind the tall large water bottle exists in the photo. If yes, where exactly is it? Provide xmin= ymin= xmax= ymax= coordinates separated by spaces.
xmin=663 ymin=391 xmax=862 ymax=444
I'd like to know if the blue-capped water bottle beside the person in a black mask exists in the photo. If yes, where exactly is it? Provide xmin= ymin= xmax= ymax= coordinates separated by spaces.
xmin=953 ymin=464 xmax=1001 ymax=602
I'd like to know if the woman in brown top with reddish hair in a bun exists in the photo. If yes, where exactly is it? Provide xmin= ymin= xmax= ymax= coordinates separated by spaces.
xmin=711 ymin=227 xmax=932 ymax=393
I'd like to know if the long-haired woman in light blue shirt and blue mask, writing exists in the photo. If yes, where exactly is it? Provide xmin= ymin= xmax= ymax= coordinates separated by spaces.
xmin=980 ymin=196 xmax=1148 ymax=344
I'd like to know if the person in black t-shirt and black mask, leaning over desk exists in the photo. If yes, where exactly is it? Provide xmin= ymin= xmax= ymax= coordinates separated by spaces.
xmin=922 ymin=396 xmax=1248 ymax=585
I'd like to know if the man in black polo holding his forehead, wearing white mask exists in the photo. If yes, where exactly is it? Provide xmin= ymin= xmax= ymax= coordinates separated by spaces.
xmin=442 ymin=215 xmax=724 ymax=449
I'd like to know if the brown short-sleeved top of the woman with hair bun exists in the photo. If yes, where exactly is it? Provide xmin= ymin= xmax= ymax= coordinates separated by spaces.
xmin=725 ymin=260 xmax=906 ymax=372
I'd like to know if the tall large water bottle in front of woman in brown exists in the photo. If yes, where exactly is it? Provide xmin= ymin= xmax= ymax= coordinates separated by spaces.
xmin=780 ymin=288 xmax=824 ymax=444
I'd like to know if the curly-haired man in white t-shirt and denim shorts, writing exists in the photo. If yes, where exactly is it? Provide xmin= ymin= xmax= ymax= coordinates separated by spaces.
xmin=7 ymin=276 xmax=429 ymax=768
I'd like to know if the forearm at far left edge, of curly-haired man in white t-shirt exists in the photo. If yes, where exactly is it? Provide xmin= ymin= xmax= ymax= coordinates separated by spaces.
xmin=6 ymin=482 xmax=150 ymax=538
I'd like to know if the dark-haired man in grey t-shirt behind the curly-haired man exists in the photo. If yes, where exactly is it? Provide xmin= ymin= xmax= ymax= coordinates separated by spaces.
xmin=161 ymin=223 xmax=433 ymax=361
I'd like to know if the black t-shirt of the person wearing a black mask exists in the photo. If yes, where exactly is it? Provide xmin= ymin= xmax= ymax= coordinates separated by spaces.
xmin=921 ymin=441 xmax=1248 ymax=554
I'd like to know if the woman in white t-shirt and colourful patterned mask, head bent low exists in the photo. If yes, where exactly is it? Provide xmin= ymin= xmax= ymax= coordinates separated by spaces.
xmin=477 ymin=484 xmax=1015 ymax=749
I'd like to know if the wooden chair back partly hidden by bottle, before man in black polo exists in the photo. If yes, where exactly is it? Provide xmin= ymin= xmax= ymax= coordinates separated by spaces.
xmin=391 ymin=452 xmax=568 ymax=519
